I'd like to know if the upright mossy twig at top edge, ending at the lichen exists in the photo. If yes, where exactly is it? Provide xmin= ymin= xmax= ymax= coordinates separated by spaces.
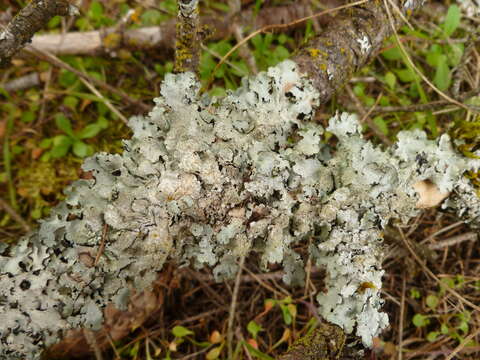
xmin=173 ymin=0 xmax=200 ymax=73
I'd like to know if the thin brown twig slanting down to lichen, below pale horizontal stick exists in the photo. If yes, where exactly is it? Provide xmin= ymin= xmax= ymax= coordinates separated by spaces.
xmin=27 ymin=46 xmax=151 ymax=111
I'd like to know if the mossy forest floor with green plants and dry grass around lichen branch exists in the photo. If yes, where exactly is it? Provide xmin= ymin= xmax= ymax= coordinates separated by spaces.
xmin=0 ymin=0 xmax=480 ymax=360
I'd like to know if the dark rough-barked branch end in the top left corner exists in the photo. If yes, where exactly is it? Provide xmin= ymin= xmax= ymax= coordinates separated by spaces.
xmin=0 ymin=0 xmax=78 ymax=67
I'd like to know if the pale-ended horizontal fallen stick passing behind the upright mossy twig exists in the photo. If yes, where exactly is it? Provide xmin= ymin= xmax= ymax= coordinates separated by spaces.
xmin=32 ymin=4 xmax=316 ymax=55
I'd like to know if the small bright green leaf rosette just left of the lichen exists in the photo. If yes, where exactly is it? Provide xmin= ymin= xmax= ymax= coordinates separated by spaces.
xmin=39 ymin=113 xmax=108 ymax=161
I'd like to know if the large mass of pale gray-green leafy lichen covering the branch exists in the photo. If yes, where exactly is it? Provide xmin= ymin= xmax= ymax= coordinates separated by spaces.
xmin=0 ymin=61 xmax=479 ymax=359
